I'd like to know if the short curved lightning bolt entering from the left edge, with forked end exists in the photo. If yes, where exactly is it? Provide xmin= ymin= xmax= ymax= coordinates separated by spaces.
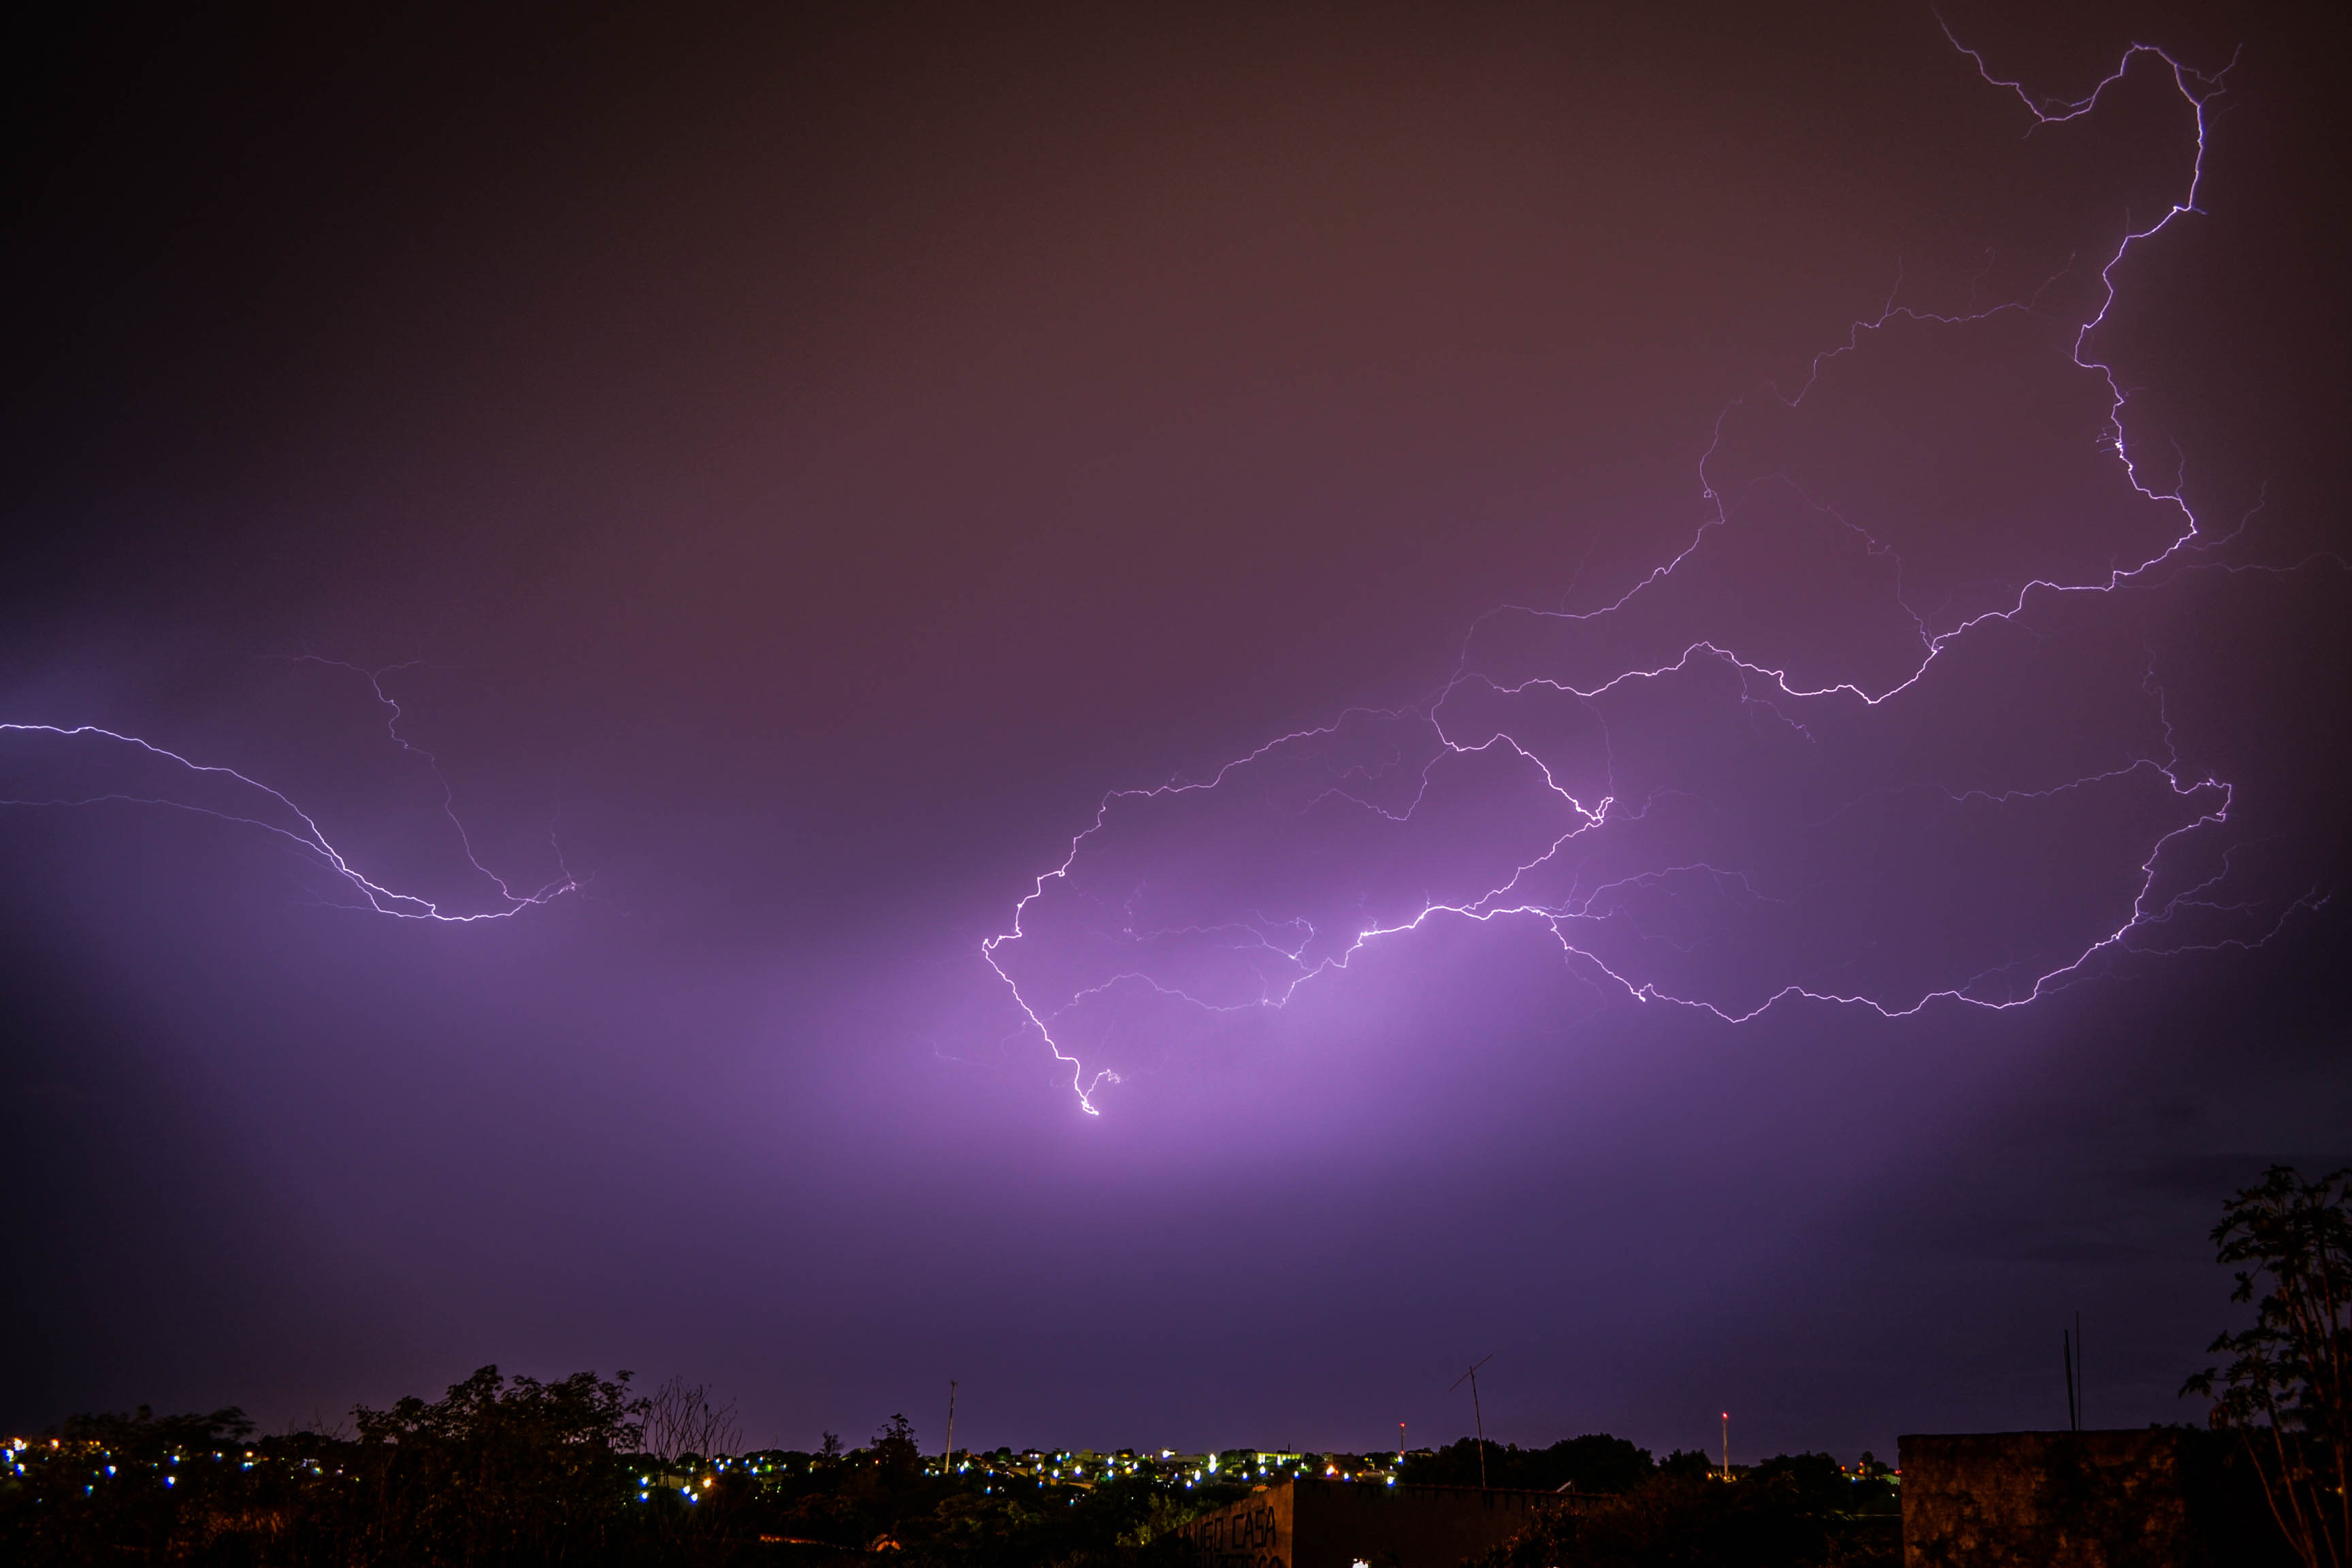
xmin=0 ymin=653 xmax=581 ymax=926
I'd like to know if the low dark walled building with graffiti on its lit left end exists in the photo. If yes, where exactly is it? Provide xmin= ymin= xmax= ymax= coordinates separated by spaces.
xmin=1178 ymin=1479 xmax=1578 ymax=1568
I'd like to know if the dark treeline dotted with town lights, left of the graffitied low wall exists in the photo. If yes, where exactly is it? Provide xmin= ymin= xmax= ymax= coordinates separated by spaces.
xmin=0 ymin=1366 xmax=1194 ymax=1568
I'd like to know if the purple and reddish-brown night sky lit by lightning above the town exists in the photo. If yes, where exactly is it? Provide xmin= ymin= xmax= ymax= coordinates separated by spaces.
xmin=0 ymin=5 xmax=2352 ymax=1460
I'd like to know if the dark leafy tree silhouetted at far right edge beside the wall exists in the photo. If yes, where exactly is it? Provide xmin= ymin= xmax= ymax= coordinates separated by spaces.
xmin=2180 ymin=1166 xmax=2352 ymax=1568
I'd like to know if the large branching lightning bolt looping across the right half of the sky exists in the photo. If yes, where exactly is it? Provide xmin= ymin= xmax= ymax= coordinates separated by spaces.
xmin=981 ymin=14 xmax=2342 ymax=1114
